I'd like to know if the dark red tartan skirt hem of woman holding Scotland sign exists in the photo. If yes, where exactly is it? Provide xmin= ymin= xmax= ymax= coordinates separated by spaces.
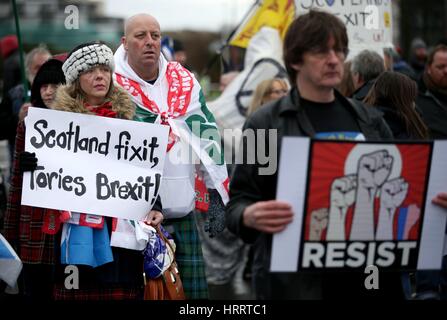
xmin=53 ymin=284 xmax=143 ymax=301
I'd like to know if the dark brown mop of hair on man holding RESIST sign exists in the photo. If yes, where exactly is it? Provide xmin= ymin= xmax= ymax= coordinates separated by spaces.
xmin=284 ymin=10 xmax=348 ymax=83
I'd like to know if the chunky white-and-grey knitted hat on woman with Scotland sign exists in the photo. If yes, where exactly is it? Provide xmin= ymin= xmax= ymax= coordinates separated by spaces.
xmin=62 ymin=42 xmax=115 ymax=84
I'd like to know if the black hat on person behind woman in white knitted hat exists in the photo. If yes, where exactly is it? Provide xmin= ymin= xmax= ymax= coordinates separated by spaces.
xmin=31 ymin=59 xmax=65 ymax=107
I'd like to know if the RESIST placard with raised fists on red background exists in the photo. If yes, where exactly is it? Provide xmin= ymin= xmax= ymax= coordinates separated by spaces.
xmin=270 ymin=137 xmax=447 ymax=272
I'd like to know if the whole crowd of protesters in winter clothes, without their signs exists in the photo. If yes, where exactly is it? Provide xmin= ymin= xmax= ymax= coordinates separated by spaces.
xmin=1 ymin=11 xmax=447 ymax=300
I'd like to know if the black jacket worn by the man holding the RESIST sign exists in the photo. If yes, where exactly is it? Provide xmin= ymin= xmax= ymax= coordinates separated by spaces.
xmin=226 ymin=88 xmax=392 ymax=299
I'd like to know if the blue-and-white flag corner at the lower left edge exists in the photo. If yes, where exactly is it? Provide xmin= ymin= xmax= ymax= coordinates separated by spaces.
xmin=0 ymin=234 xmax=23 ymax=287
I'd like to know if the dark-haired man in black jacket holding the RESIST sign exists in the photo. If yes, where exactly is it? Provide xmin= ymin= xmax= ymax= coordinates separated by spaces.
xmin=227 ymin=11 xmax=392 ymax=299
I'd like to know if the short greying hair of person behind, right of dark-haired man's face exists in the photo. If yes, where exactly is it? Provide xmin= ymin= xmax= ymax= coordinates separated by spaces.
xmin=351 ymin=50 xmax=385 ymax=83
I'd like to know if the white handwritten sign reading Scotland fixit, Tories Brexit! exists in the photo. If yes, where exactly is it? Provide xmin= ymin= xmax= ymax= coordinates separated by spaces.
xmin=22 ymin=108 xmax=169 ymax=220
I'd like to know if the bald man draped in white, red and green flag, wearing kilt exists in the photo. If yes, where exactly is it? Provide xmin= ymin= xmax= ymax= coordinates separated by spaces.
xmin=114 ymin=14 xmax=229 ymax=299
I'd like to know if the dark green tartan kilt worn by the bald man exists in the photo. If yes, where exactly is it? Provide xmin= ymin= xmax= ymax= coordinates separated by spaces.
xmin=163 ymin=212 xmax=208 ymax=299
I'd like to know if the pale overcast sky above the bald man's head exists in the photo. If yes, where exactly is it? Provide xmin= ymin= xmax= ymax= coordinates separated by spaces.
xmin=104 ymin=0 xmax=255 ymax=31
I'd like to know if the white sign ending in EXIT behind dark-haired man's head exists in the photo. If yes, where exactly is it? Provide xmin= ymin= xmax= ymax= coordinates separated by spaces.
xmin=295 ymin=0 xmax=393 ymax=57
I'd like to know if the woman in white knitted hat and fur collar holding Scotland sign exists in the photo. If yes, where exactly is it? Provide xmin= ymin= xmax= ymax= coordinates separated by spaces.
xmin=54 ymin=43 xmax=163 ymax=300
